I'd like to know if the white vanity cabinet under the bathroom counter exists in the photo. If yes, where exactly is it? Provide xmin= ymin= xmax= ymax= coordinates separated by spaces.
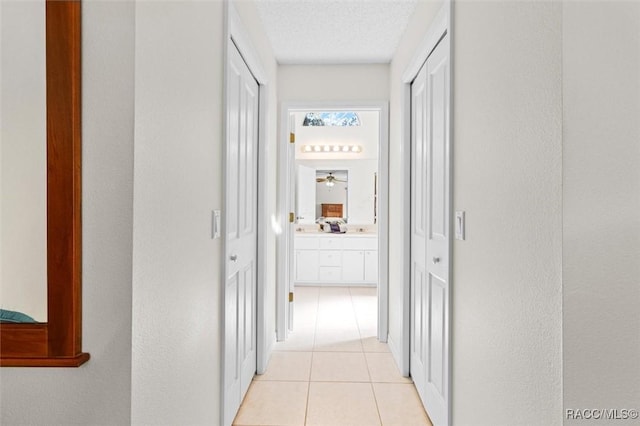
xmin=294 ymin=233 xmax=378 ymax=285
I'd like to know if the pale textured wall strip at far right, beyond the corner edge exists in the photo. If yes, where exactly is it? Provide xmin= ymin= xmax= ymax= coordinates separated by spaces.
xmin=562 ymin=2 xmax=640 ymax=424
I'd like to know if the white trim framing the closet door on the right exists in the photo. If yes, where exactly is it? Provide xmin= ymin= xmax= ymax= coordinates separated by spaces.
xmin=398 ymin=0 xmax=454 ymax=419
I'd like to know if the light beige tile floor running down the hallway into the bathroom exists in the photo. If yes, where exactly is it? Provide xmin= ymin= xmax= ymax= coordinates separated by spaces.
xmin=234 ymin=287 xmax=431 ymax=426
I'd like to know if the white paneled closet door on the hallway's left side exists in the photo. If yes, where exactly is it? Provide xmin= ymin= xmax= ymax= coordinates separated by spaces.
xmin=224 ymin=43 xmax=259 ymax=424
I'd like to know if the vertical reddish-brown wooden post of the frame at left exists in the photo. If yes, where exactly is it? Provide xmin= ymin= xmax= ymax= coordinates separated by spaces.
xmin=47 ymin=1 xmax=82 ymax=356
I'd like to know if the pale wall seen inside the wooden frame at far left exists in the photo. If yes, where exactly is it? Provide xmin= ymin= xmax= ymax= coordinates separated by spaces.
xmin=0 ymin=1 xmax=47 ymax=322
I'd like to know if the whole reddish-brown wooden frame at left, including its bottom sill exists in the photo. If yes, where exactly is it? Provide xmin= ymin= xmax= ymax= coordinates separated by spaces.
xmin=0 ymin=0 xmax=89 ymax=367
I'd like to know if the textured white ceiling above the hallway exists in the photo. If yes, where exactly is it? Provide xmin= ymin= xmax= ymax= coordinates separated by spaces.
xmin=256 ymin=0 xmax=418 ymax=64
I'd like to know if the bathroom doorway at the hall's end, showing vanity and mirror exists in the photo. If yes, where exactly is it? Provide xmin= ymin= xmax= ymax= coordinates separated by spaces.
xmin=277 ymin=102 xmax=388 ymax=342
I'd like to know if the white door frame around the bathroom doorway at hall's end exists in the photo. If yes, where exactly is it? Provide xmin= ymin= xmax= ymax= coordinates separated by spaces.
xmin=276 ymin=101 xmax=389 ymax=342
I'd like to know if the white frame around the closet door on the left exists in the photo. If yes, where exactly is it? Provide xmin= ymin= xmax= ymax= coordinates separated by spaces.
xmin=219 ymin=1 xmax=273 ymax=426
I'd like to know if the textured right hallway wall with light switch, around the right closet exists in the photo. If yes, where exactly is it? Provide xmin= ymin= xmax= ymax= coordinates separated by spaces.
xmin=390 ymin=1 xmax=562 ymax=425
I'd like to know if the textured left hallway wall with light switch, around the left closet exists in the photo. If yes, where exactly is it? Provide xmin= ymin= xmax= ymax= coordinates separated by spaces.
xmin=132 ymin=1 xmax=276 ymax=425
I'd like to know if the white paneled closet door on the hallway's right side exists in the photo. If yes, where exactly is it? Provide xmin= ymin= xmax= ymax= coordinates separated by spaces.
xmin=410 ymin=36 xmax=450 ymax=425
